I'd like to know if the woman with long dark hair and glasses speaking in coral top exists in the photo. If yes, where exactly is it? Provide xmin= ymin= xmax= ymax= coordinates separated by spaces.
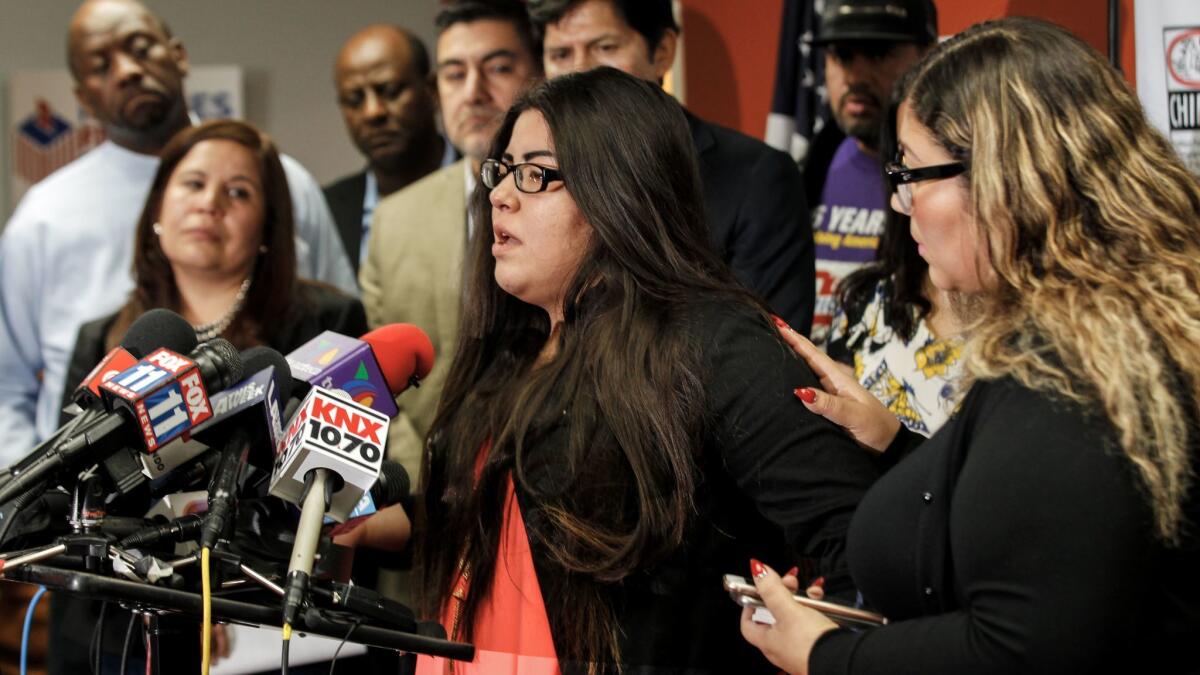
xmin=415 ymin=68 xmax=876 ymax=675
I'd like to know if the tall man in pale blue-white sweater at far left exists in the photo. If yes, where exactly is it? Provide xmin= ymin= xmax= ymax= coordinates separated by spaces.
xmin=0 ymin=0 xmax=358 ymax=458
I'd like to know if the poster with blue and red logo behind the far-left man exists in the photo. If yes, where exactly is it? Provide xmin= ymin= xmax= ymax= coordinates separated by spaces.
xmin=7 ymin=66 xmax=244 ymax=210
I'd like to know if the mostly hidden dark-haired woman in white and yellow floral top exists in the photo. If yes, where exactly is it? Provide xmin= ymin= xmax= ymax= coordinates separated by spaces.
xmin=826 ymin=88 xmax=962 ymax=436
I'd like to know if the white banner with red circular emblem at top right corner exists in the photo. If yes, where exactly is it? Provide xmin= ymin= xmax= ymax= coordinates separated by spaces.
xmin=1134 ymin=0 xmax=1200 ymax=174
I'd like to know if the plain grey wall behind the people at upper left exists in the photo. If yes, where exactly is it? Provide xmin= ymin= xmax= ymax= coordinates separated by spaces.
xmin=0 ymin=0 xmax=439 ymax=212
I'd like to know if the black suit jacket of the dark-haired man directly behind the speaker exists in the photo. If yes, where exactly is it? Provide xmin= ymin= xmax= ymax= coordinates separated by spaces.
xmin=685 ymin=110 xmax=816 ymax=335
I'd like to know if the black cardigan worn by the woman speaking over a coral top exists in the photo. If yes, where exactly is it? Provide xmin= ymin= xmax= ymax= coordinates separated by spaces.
xmin=470 ymin=303 xmax=878 ymax=674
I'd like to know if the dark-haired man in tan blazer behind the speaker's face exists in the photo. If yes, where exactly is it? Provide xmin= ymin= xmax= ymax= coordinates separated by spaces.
xmin=359 ymin=0 xmax=541 ymax=476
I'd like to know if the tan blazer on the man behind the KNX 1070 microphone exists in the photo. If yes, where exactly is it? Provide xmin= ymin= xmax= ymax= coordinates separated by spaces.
xmin=359 ymin=160 xmax=467 ymax=490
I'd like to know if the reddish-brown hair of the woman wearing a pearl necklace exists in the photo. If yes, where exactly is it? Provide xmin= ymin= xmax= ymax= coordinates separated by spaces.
xmin=108 ymin=120 xmax=296 ymax=347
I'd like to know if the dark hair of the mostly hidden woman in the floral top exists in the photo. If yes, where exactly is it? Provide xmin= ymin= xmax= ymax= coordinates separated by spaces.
xmin=835 ymin=71 xmax=934 ymax=345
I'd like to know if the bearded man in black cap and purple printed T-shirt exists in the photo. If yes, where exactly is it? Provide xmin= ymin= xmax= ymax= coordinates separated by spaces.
xmin=804 ymin=0 xmax=937 ymax=345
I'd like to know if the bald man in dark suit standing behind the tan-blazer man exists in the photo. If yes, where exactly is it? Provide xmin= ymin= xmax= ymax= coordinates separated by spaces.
xmin=325 ymin=25 xmax=457 ymax=273
